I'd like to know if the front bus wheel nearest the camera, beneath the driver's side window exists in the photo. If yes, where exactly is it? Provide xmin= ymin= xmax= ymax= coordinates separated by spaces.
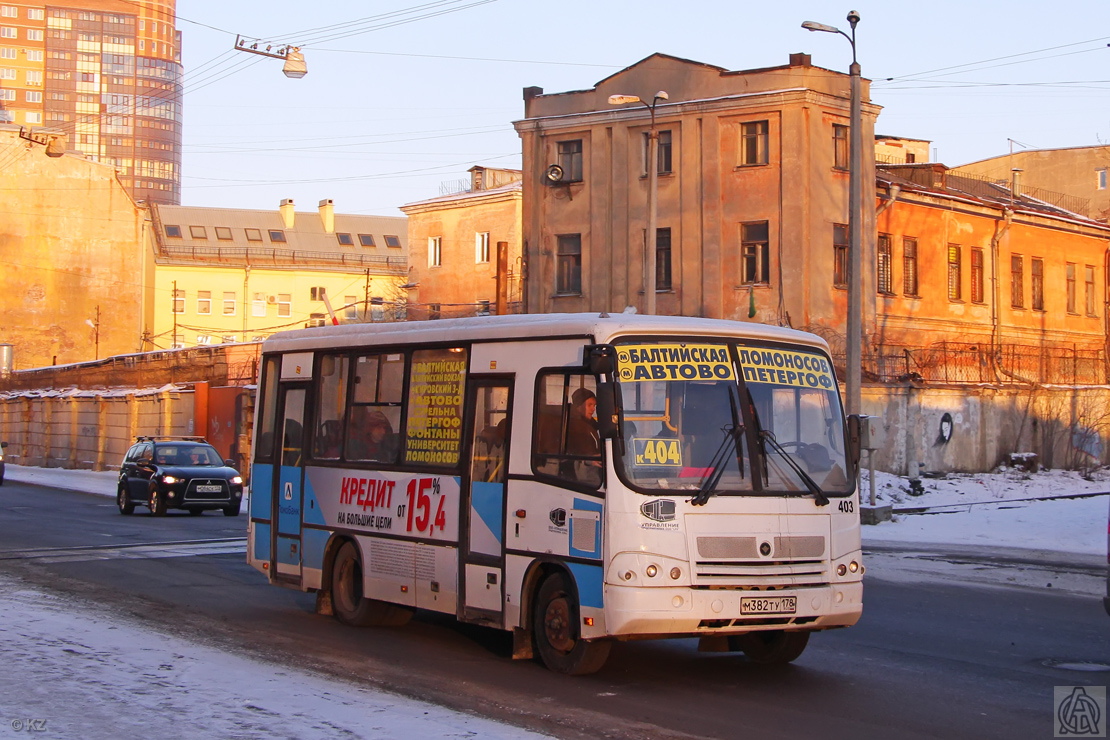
xmin=532 ymin=574 xmax=612 ymax=676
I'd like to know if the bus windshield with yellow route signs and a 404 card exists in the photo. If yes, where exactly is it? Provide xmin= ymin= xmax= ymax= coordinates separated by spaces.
xmin=616 ymin=341 xmax=852 ymax=496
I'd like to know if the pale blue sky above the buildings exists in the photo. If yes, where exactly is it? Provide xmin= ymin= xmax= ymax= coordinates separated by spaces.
xmin=178 ymin=0 xmax=1110 ymax=215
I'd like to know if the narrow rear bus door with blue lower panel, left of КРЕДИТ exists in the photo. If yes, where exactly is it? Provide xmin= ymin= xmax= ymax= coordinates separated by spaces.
xmin=270 ymin=384 xmax=307 ymax=582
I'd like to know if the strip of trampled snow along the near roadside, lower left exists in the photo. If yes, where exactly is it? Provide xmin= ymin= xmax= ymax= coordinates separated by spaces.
xmin=0 ymin=577 xmax=545 ymax=740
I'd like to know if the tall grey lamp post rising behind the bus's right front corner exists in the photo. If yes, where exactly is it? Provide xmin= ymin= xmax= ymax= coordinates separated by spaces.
xmin=801 ymin=10 xmax=864 ymax=414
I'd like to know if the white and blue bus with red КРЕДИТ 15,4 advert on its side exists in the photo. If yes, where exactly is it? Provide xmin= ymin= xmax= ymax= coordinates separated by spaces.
xmin=248 ymin=314 xmax=864 ymax=675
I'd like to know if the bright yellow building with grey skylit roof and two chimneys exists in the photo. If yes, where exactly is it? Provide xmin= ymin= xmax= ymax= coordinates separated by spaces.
xmin=144 ymin=200 xmax=408 ymax=349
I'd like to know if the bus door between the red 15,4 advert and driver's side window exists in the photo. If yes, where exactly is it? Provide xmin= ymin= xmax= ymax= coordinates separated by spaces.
xmin=458 ymin=378 xmax=512 ymax=627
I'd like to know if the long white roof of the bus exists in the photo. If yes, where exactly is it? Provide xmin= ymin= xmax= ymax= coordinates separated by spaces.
xmin=262 ymin=313 xmax=828 ymax=352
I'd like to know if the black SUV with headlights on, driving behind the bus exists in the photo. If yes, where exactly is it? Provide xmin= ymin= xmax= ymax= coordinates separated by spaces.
xmin=115 ymin=437 xmax=243 ymax=517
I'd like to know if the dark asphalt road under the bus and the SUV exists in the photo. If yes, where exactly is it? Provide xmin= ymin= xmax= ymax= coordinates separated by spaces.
xmin=0 ymin=481 xmax=1110 ymax=739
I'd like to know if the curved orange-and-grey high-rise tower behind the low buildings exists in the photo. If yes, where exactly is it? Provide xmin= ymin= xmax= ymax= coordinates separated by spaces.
xmin=0 ymin=0 xmax=181 ymax=204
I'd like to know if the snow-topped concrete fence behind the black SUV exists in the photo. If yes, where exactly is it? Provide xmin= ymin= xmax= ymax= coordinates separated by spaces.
xmin=0 ymin=386 xmax=195 ymax=470
